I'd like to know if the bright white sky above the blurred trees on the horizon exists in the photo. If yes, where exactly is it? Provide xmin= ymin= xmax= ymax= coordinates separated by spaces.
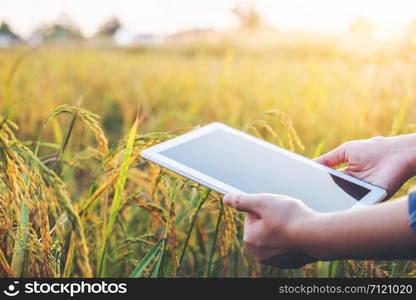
xmin=0 ymin=0 xmax=416 ymax=37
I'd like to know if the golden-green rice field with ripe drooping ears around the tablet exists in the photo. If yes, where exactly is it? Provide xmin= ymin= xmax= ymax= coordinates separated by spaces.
xmin=0 ymin=44 xmax=416 ymax=277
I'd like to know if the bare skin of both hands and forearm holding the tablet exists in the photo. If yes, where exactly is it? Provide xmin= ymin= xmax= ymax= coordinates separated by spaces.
xmin=224 ymin=134 xmax=416 ymax=268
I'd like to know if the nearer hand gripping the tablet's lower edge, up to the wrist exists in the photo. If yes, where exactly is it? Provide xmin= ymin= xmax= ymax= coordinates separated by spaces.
xmin=224 ymin=193 xmax=319 ymax=268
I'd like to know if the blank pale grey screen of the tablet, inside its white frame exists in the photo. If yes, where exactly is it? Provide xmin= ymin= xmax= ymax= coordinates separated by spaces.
xmin=160 ymin=129 xmax=370 ymax=212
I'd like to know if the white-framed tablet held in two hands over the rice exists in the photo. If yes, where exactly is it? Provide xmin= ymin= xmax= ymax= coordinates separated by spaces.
xmin=141 ymin=123 xmax=387 ymax=212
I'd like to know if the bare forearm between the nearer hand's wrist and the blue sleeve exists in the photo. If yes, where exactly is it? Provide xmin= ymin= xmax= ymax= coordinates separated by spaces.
xmin=296 ymin=197 xmax=416 ymax=260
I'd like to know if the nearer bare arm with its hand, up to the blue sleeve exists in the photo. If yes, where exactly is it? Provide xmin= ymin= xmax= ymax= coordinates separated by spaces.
xmin=224 ymin=194 xmax=416 ymax=268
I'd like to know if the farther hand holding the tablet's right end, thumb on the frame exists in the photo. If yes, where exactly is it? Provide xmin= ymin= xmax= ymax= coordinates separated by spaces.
xmin=315 ymin=134 xmax=416 ymax=197
